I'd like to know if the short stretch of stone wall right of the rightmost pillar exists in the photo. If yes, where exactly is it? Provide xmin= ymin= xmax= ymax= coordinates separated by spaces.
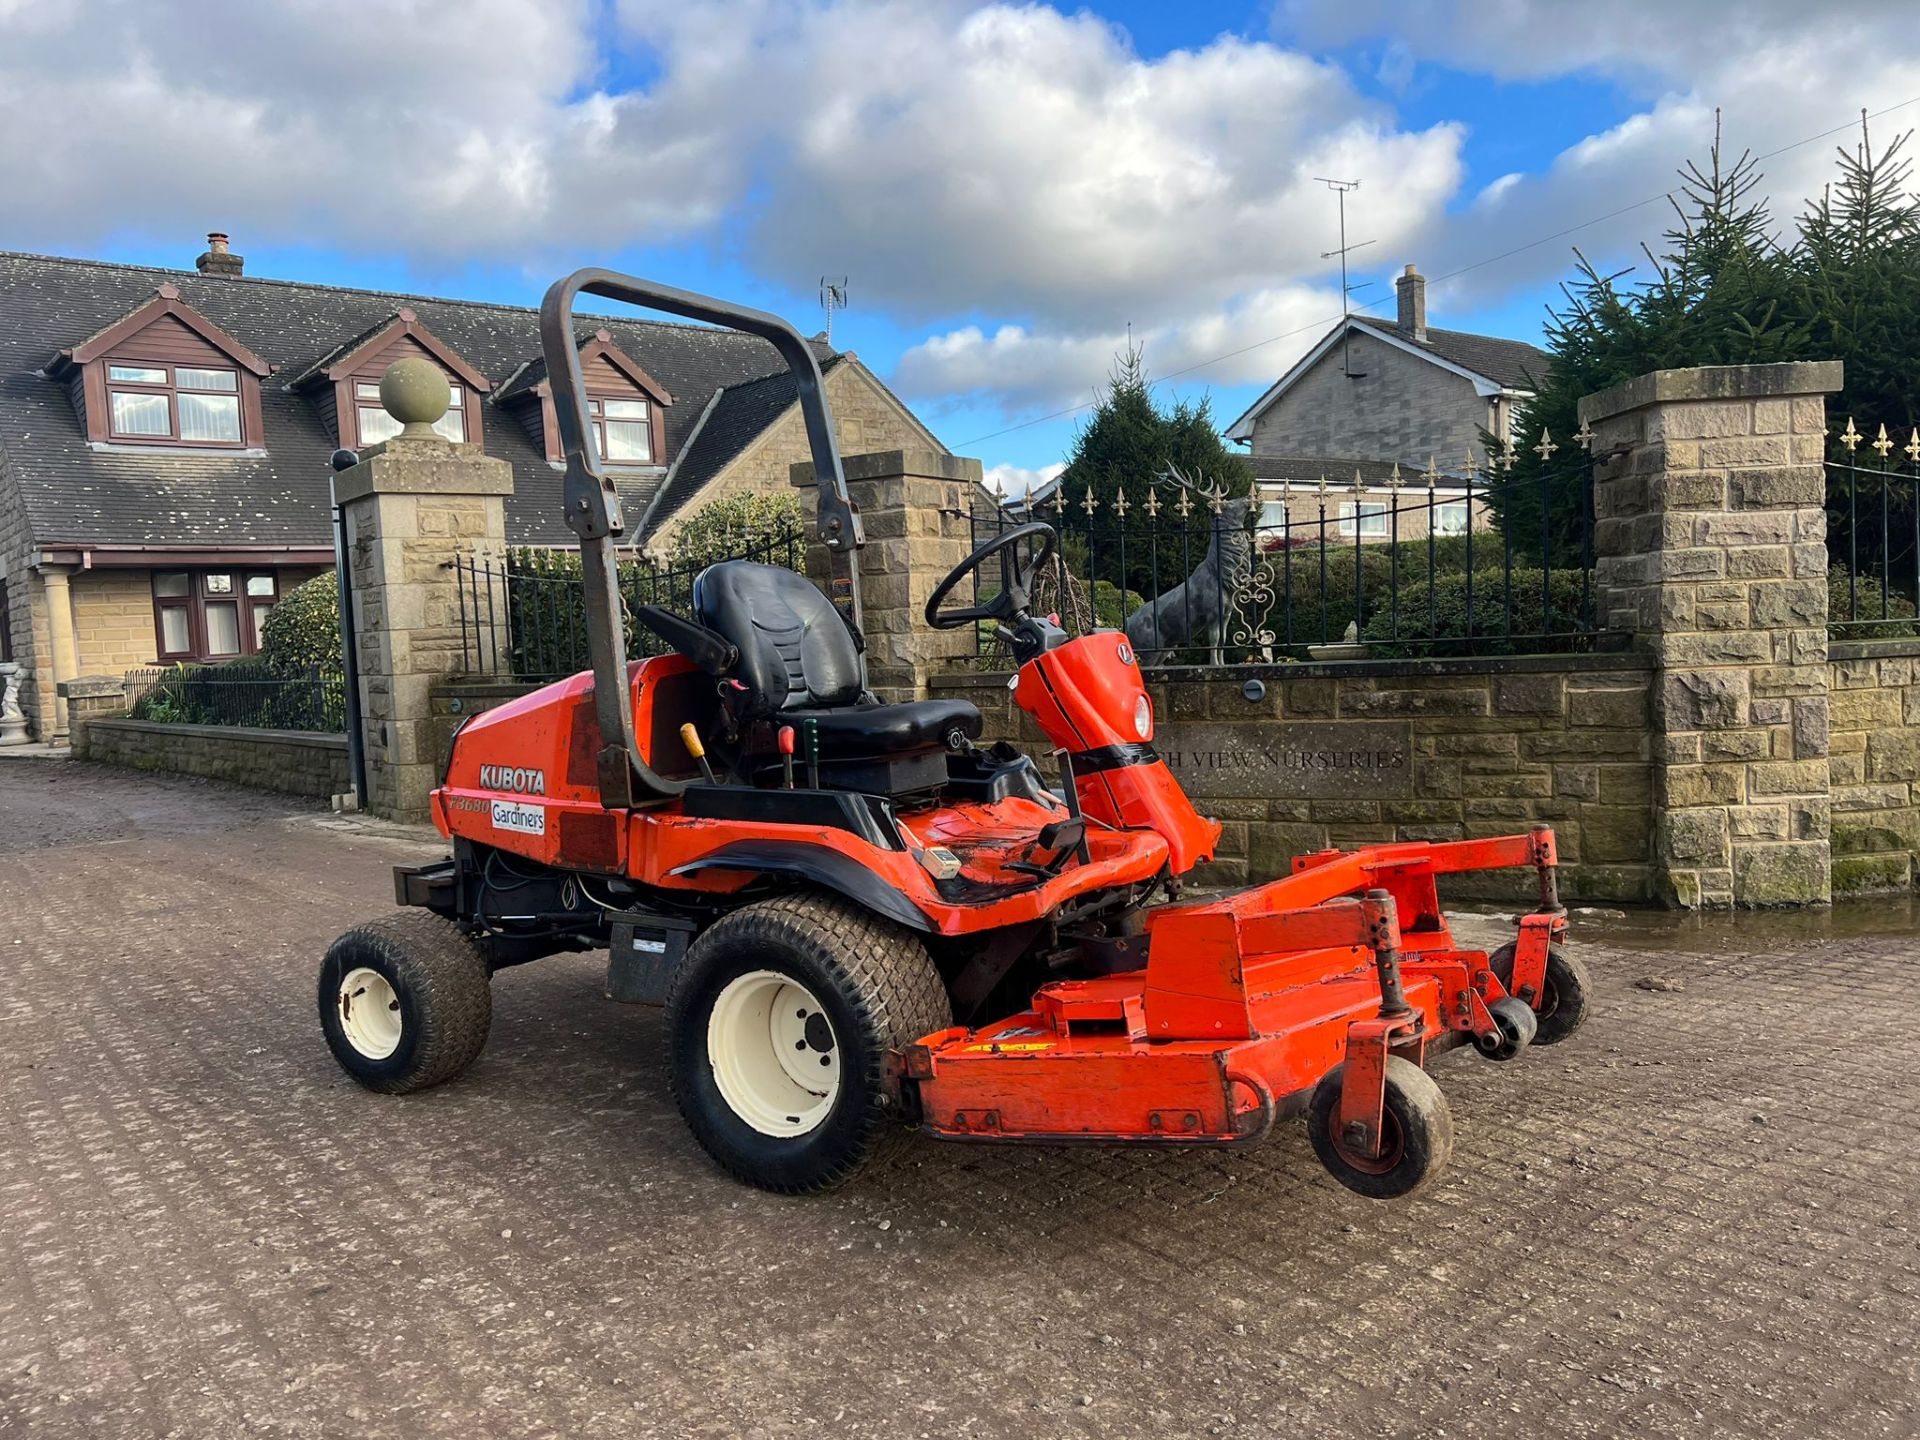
xmin=1828 ymin=639 xmax=1920 ymax=895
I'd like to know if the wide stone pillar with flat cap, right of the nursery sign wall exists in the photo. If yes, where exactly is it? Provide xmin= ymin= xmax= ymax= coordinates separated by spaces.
xmin=1580 ymin=361 xmax=1841 ymax=908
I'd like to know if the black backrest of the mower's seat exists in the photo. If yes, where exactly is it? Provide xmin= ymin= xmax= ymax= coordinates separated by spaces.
xmin=693 ymin=561 xmax=866 ymax=714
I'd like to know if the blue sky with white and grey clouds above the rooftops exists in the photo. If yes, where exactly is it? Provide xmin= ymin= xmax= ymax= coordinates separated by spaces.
xmin=0 ymin=0 xmax=1920 ymax=491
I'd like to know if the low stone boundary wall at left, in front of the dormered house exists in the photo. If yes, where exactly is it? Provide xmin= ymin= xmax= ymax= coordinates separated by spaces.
xmin=73 ymin=716 xmax=353 ymax=799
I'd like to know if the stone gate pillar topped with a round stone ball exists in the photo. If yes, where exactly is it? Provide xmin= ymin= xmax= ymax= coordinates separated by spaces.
xmin=334 ymin=359 xmax=513 ymax=820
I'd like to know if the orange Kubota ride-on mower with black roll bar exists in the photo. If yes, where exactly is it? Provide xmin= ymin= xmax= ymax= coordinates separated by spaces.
xmin=319 ymin=271 xmax=1588 ymax=1198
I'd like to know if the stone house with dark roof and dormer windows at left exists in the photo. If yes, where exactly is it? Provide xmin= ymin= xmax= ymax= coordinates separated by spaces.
xmin=0 ymin=234 xmax=945 ymax=737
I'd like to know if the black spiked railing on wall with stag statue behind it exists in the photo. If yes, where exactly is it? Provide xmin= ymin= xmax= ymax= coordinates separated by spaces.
xmin=948 ymin=453 xmax=1605 ymax=664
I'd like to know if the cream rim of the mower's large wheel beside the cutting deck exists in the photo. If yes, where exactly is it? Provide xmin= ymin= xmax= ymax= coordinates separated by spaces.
xmin=707 ymin=970 xmax=841 ymax=1139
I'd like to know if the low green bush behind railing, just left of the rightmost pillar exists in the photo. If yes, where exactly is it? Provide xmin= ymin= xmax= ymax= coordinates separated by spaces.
xmin=1359 ymin=566 xmax=1586 ymax=657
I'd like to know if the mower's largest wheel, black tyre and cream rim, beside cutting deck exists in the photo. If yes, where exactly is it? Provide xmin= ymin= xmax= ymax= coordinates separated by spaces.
xmin=666 ymin=895 xmax=952 ymax=1194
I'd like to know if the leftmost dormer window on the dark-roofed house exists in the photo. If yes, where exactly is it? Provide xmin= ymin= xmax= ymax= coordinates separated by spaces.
xmin=46 ymin=284 xmax=271 ymax=449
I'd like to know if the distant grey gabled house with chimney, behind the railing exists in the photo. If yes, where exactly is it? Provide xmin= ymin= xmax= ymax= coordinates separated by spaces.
xmin=1227 ymin=265 xmax=1549 ymax=540
